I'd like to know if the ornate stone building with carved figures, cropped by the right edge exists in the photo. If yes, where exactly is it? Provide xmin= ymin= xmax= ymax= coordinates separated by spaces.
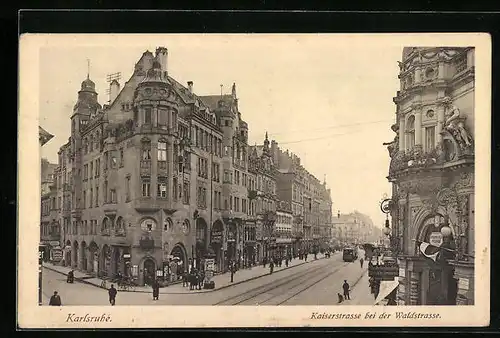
xmin=386 ymin=47 xmax=474 ymax=305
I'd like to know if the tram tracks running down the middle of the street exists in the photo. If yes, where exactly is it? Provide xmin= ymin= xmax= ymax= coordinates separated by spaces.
xmin=215 ymin=263 xmax=349 ymax=305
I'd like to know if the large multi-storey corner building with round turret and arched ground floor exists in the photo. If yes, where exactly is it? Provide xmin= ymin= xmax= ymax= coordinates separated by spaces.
xmin=55 ymin=47 xmax=249 ymax=284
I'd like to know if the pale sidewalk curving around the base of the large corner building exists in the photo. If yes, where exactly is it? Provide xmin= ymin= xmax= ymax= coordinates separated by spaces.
xmin=43 ymin=253 xmax=330 ymax=294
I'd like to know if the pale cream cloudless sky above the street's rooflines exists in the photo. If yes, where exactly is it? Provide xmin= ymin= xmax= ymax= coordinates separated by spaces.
xmin=39 ymin=35 xmax=403 ymax=226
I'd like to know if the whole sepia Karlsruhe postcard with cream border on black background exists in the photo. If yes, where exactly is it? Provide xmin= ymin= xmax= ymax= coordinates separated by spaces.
xmin=18 ymin=34 xmax=491 ymax=328
